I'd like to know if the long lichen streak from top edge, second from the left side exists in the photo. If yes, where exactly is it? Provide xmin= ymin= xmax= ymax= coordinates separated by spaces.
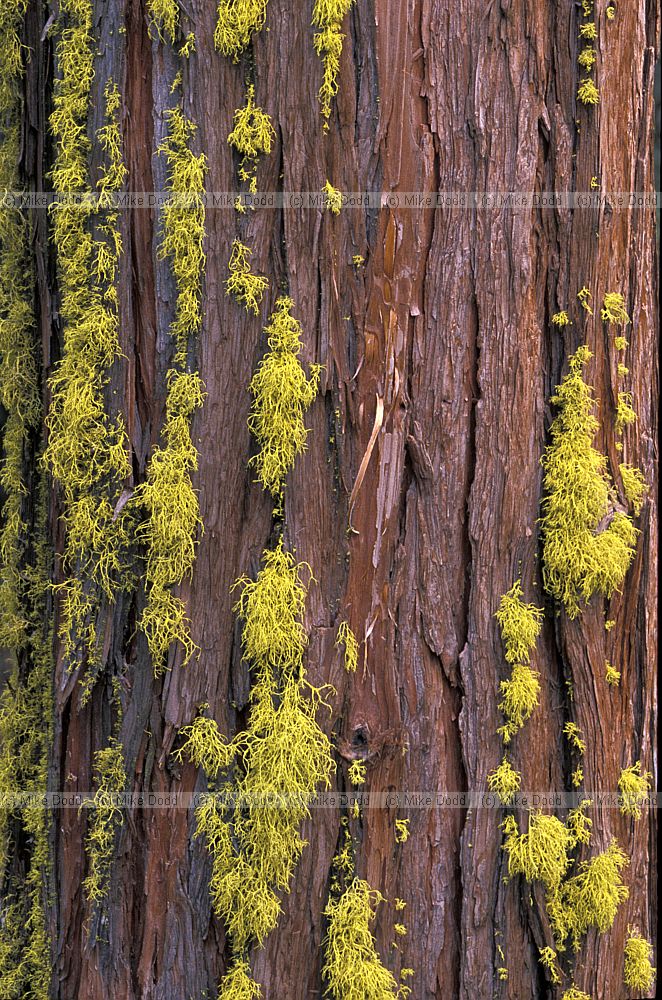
xmin=44 ymin=0 xmax=131 ymax=672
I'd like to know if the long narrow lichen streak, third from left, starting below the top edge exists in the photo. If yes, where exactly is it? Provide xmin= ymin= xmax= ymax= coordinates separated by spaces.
xmin=132 ymin=108 xmax=206 ymax=673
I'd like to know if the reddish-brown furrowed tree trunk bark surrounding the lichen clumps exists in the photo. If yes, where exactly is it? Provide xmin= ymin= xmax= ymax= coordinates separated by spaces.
xmin=0 ymin=0 xmax=660 ymax=1000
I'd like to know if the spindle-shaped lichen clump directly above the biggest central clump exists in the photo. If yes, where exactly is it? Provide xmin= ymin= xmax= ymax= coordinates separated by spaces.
xmin=248 ymin=296 xmax=321 ymax=499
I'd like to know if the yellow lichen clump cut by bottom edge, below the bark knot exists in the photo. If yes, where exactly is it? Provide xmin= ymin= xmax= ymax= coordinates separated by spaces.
xmin=322 ymin=878 xmax=399 ymax=1000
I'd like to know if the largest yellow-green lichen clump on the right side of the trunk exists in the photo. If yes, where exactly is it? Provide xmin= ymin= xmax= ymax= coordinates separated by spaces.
xmin=542 ymin=347 xmax=637 ymax=618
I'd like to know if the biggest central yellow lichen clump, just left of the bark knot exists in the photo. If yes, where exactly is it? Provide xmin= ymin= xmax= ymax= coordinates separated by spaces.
xmin=179 ymin=539 xmax=334 ymax=972
